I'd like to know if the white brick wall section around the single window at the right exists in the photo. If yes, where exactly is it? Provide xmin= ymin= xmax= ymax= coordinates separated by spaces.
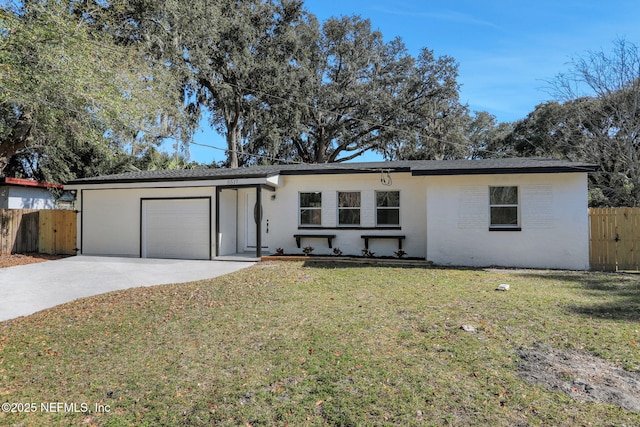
xmin=426 ymin=173 xmax=589 ymax=270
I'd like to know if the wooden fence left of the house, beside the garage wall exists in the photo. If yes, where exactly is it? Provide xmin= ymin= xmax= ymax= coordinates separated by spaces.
xmin=0 ymin=209 xmax=76 ymax=255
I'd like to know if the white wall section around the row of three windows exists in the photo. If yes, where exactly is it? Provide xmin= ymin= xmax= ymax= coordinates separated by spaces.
xmin=268 ymin=172 xmax=426 ymax=257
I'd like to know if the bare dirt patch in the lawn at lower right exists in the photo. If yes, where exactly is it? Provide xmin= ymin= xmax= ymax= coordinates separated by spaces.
xmin=518 ymin=344 xmax=640 ymax=412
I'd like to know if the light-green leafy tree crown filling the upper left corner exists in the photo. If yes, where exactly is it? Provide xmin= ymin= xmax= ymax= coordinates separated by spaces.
xmin=0 ymin=1 xmax=185 ymax=181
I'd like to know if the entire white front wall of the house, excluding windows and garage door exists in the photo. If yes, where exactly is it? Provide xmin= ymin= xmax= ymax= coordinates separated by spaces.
xmin=74 ymin=172 xmax=589 ymax=269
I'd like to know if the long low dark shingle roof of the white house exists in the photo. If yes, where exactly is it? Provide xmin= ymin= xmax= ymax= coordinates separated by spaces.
xmin=67 ymin=157 xmax=599 ymax=185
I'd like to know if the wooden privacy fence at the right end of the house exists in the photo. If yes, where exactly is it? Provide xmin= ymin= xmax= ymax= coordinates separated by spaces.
xmin=589 ymin=208 xmax=640 ymax=271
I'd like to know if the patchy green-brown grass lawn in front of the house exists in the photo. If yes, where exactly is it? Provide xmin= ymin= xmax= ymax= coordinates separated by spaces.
xmin=0 ymin=263 xmax=640 ymax=426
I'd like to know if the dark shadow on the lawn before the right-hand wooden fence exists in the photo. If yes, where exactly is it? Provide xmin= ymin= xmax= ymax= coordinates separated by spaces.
xmin=522 ymin=272 xmax=640 ymax=322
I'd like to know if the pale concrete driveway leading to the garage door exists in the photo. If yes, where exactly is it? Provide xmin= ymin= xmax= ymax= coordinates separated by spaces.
xmin=0 ymin=256 xmax=254 ymax=322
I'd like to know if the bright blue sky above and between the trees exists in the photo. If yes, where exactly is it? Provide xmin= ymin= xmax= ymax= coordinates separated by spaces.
xmin=182 ymin=0 xmax=640 ymax=163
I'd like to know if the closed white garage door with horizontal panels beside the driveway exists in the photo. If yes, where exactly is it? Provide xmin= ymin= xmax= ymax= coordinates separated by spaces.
xmin=141 ymin=198 xmax=211 ymax=259
